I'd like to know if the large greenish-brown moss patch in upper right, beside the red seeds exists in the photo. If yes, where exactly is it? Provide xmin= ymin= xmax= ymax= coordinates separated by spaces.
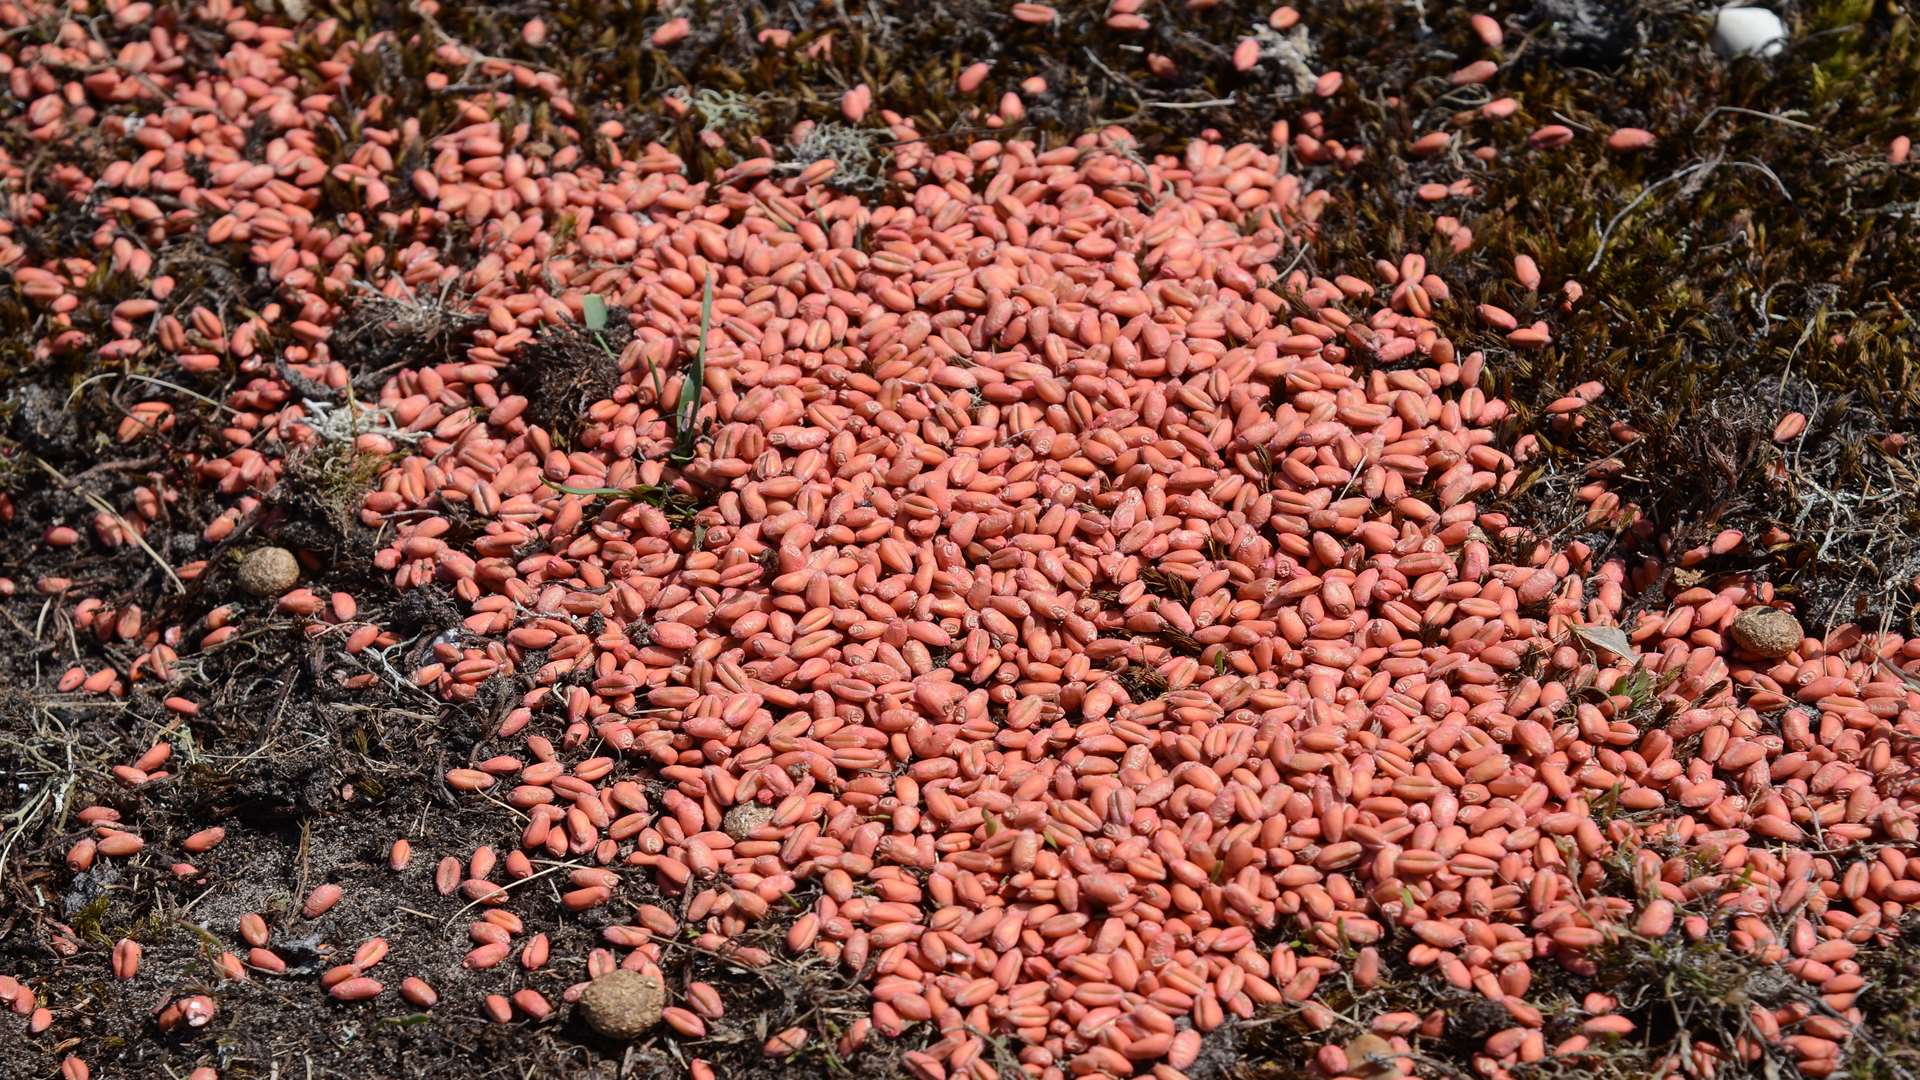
xmin=1309 ymin=0 xmax=1920 ymax=626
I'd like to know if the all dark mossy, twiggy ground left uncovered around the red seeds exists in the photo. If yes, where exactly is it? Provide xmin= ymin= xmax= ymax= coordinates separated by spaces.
xmin=0 ymin=0 xmax=1920 ymax=1078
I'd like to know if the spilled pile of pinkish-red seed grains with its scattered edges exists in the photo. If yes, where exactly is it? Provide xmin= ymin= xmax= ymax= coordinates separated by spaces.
xmin=0 ymin=0 xmax=1920 ymax=1080
